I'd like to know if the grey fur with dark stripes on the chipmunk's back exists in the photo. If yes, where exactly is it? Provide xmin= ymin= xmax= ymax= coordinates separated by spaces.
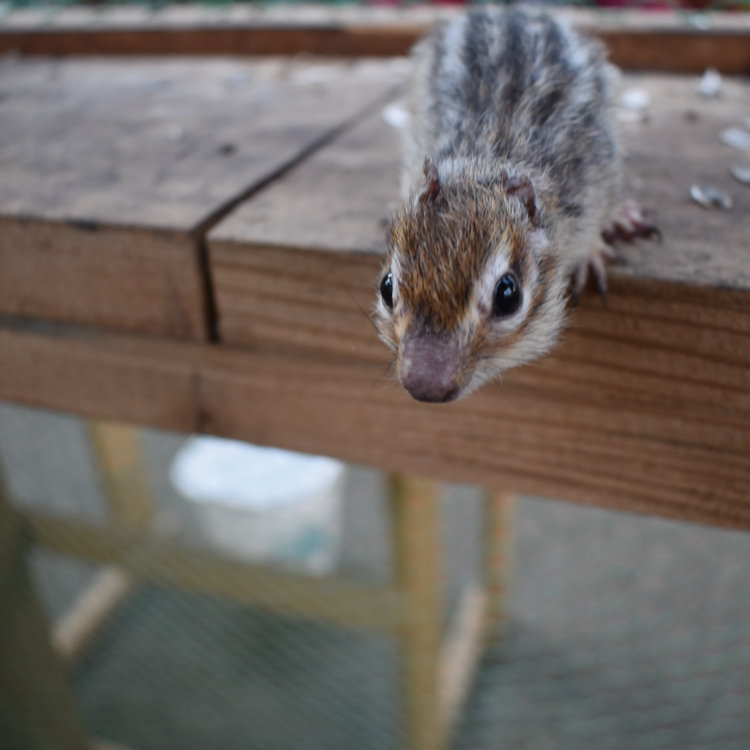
xmin=402 ymin=8 xmax=619 ymax=265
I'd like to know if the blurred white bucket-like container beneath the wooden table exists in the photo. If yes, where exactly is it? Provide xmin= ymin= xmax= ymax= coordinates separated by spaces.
xmin=170 ymin=437 xmax=345 ymax=574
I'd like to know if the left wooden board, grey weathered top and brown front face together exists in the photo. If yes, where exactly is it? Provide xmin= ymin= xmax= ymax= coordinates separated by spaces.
xmin=0 ymin=59 xmax=403 ymax=338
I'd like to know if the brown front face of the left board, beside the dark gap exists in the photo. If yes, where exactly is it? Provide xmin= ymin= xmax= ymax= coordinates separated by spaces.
xmin=0 ymin=220 xmax=207 ymax=339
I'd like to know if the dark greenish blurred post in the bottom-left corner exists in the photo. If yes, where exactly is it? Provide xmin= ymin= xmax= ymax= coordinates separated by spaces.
xmin=0 ymin=476 xmax=89 ymax=750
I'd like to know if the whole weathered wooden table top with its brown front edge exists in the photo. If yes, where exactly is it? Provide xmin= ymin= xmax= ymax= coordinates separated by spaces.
xmin=0 ymin=58 xmax=750 ymax=528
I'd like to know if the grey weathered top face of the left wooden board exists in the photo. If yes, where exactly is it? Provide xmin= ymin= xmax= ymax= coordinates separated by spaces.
xmin=0 ymin=59 xmax=403 ymax=231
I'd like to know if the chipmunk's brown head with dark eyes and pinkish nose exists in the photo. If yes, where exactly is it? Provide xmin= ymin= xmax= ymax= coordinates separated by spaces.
xmin=375 ymin=159 xmax=565 ymax=402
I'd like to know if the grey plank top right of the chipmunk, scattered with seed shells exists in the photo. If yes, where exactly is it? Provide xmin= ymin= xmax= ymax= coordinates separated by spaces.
xmin=617 ymin=73 xmax=750 ymax=289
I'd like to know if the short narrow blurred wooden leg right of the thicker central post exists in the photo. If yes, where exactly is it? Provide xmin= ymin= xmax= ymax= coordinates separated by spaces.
xmin=484 ymin=491 xmax=515 ymax=637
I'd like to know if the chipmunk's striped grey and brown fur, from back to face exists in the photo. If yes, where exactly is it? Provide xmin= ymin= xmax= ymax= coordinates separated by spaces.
xmin=376 ymin=8 xmax=620 ymax=406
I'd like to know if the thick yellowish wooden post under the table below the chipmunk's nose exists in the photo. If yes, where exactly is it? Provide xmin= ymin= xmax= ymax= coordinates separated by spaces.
xmin=390 ymin=475 xmax=444 ymax=750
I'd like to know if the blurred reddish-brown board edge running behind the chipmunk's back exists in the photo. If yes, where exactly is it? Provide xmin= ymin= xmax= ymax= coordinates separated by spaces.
xmin=0 ymin=11 xmax=750 ymax=75
